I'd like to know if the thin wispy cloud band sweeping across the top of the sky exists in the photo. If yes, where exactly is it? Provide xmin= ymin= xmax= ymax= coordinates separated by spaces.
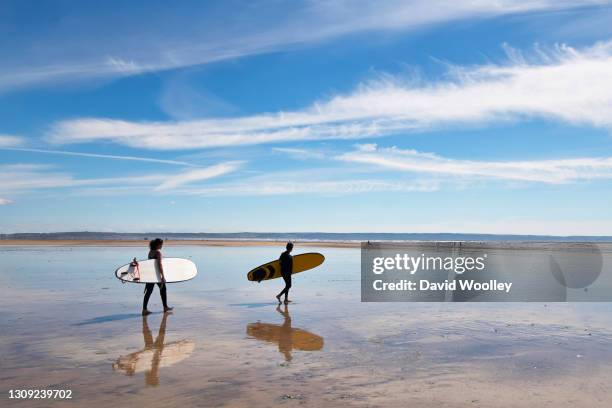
xmin=0 ymin=0 xmax=609 ymax=91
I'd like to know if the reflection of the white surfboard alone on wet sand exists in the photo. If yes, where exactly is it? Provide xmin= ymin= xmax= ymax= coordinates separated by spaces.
xmin=113 ymin=340 xmax=195 ymax=375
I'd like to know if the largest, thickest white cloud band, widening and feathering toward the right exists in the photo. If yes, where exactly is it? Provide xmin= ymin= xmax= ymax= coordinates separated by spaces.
xmin=48 ymin=42 xmax=612 ymax=150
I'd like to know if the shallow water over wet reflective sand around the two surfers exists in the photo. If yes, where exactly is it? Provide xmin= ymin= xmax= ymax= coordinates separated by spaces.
xmin=0 ymin=246 xmax=612 ymax=407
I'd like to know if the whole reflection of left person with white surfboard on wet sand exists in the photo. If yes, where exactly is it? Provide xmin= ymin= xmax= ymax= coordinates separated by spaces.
xmin=113 ymin=313 xmax=195 ymax=386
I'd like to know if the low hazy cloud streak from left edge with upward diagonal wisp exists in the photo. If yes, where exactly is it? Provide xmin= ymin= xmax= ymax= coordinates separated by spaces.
xmin=0 ymin=162 xmax=440 ymax=197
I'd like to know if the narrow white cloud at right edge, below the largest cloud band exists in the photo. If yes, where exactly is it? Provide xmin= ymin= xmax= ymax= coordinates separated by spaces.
xmin=337 ymin=145 xmax=612 ymax=183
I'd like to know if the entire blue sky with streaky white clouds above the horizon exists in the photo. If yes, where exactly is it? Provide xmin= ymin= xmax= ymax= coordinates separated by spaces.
xmin=0 ymin=0 xmax=612 ymax=235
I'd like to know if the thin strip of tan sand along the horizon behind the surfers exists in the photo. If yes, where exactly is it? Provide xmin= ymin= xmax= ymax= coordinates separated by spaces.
xmin=0 ymin=239 xmax=360 ymax=248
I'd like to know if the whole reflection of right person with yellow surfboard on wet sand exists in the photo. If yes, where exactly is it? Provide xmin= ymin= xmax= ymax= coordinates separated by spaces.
xmin=247 ymin=305 xmax=323 ymax=361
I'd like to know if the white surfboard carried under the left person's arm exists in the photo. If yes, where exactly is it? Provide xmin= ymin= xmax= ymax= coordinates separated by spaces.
xmin=115 ymin=258 xmax=198 ymax=283
